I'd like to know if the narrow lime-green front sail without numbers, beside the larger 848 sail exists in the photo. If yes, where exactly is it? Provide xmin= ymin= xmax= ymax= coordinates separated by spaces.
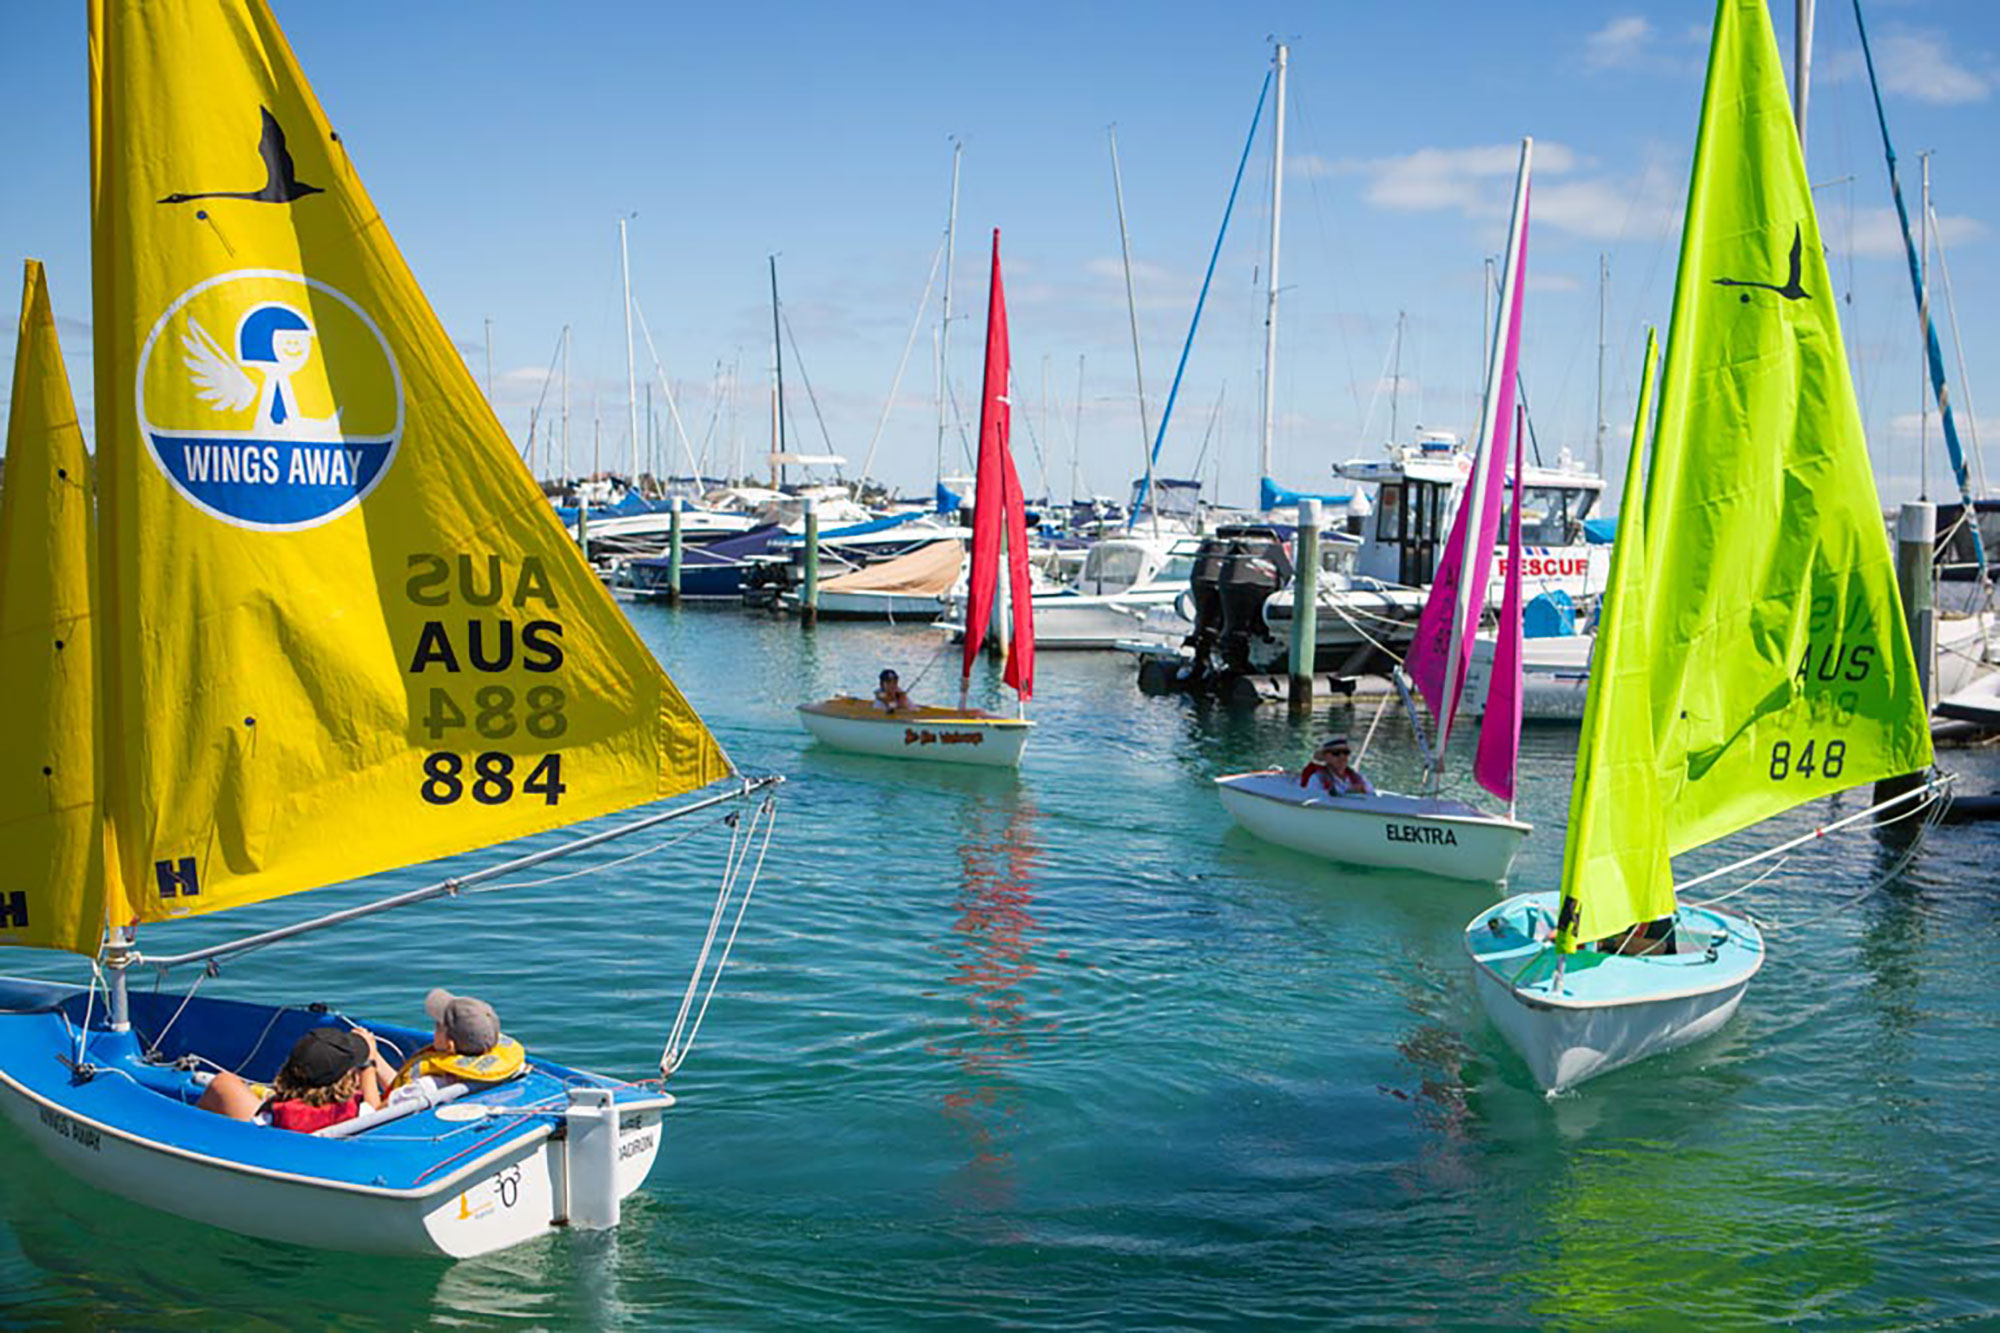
xmin=1556 ymin=330 xmax=1674 ymax=953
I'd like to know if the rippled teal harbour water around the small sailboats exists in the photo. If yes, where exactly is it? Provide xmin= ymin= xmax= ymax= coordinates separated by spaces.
xmin=0 ymin=606 xmax=2000 ymax=1329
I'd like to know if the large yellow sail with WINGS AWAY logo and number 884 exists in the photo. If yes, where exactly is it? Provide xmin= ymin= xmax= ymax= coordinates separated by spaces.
xmin=90 ymin=0 xmax=730 ymax=921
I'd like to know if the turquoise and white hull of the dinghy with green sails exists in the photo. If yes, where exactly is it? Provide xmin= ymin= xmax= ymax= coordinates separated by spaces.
xmin=1466 ymin=893 xmax=1764 ymax=1093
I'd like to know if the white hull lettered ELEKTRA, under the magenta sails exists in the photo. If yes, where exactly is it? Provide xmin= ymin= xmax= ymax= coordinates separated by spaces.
xmin=1216 ymin=773 xmax=1532 ymax=883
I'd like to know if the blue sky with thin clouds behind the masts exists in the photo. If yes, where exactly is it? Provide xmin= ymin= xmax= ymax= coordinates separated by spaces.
xmin=0 ymin=0 xmax=2000 ymax=502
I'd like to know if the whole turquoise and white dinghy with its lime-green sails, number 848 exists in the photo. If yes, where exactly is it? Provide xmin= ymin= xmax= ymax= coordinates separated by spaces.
xmin=1466 ymin=0 xmax=1942 ymax=1091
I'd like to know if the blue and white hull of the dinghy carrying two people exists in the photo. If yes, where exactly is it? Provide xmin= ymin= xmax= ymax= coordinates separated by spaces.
xmin=0 ymin=979 xmax=674 ymax=1259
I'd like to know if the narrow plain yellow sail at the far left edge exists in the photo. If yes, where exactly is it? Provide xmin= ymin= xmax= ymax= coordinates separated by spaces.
xmin=0 ymin=260 xmax=120 ymax=953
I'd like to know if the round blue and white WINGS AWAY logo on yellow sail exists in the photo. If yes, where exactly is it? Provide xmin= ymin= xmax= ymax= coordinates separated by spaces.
xmin=138 ymin=268 xmax=402 ymax=532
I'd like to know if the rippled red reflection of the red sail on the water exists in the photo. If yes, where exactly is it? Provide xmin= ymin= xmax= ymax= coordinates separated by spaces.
xmin=930 ymin=795 xmax=1054 ymax=1211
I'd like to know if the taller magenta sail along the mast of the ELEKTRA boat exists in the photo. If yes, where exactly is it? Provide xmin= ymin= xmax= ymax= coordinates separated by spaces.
xmin=1406 ymin=171 xmax=1528 ymax=740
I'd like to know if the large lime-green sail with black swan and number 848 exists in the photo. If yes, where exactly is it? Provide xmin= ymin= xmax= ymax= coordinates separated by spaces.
xmin=1632 ymin=0 xmax=1930 ymax=852
